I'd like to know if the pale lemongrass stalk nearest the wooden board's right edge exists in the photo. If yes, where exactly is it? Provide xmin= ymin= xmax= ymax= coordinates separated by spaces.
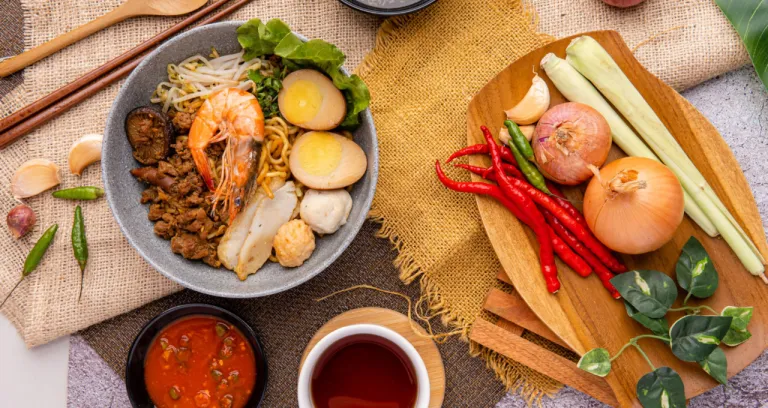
xmin=566 ymin=36 xmax=765 ymax=276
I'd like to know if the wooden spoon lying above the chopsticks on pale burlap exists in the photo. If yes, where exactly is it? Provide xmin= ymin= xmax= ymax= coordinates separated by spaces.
xmin=0 ymin=0 xmax=207 ymax=77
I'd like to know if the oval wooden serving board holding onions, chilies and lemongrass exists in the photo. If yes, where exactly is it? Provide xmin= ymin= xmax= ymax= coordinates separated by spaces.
xmin=467 ymin=31 xmax=768 ymax=406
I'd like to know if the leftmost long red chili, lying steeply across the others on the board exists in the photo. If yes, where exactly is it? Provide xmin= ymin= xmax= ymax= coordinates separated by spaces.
xmin=480 ymin=126 xmax=560 ymax=293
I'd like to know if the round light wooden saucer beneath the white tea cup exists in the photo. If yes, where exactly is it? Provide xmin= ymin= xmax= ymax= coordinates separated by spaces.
xmin=301 ymin=307 xmax=445 ymax=408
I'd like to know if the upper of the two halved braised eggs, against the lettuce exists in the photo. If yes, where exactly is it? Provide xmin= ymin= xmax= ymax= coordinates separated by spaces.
xmin=277 ymin=69 xmax=347 ymax=130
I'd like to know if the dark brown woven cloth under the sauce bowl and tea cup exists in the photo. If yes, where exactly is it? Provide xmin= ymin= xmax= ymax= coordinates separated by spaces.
xmin=80 ymin=222 xmax=505 ymax=408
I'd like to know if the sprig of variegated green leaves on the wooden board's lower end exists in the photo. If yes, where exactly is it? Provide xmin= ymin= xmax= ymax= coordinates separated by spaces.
xmin=578 ymin=237 xmax=753 ymax=408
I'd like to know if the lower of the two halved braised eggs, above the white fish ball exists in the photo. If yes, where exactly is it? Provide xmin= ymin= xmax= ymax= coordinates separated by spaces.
xmin=288 ymin=132 xmax=368 ymax=190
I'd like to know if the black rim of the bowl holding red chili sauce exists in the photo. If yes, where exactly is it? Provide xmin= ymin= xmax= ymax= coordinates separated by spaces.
xmin=125 ymin=303 xmax=267 ymax=408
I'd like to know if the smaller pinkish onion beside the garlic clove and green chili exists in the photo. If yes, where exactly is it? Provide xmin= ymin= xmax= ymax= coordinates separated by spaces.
xmin=533 ymin=102 xmax=611 ymax=186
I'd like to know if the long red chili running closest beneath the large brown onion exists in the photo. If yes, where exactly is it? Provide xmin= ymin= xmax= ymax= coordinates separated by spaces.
xmin=459 ymin=156 xmax=627 ymax=273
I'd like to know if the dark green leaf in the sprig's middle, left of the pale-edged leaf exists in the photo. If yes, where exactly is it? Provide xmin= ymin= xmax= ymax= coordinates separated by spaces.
xmin=669 ymin=316 xmax=733 ymax=361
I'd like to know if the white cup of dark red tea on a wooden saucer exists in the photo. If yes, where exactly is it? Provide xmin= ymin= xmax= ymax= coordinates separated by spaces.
xmin=298 ymin=324 xmax=430 ymax=408
